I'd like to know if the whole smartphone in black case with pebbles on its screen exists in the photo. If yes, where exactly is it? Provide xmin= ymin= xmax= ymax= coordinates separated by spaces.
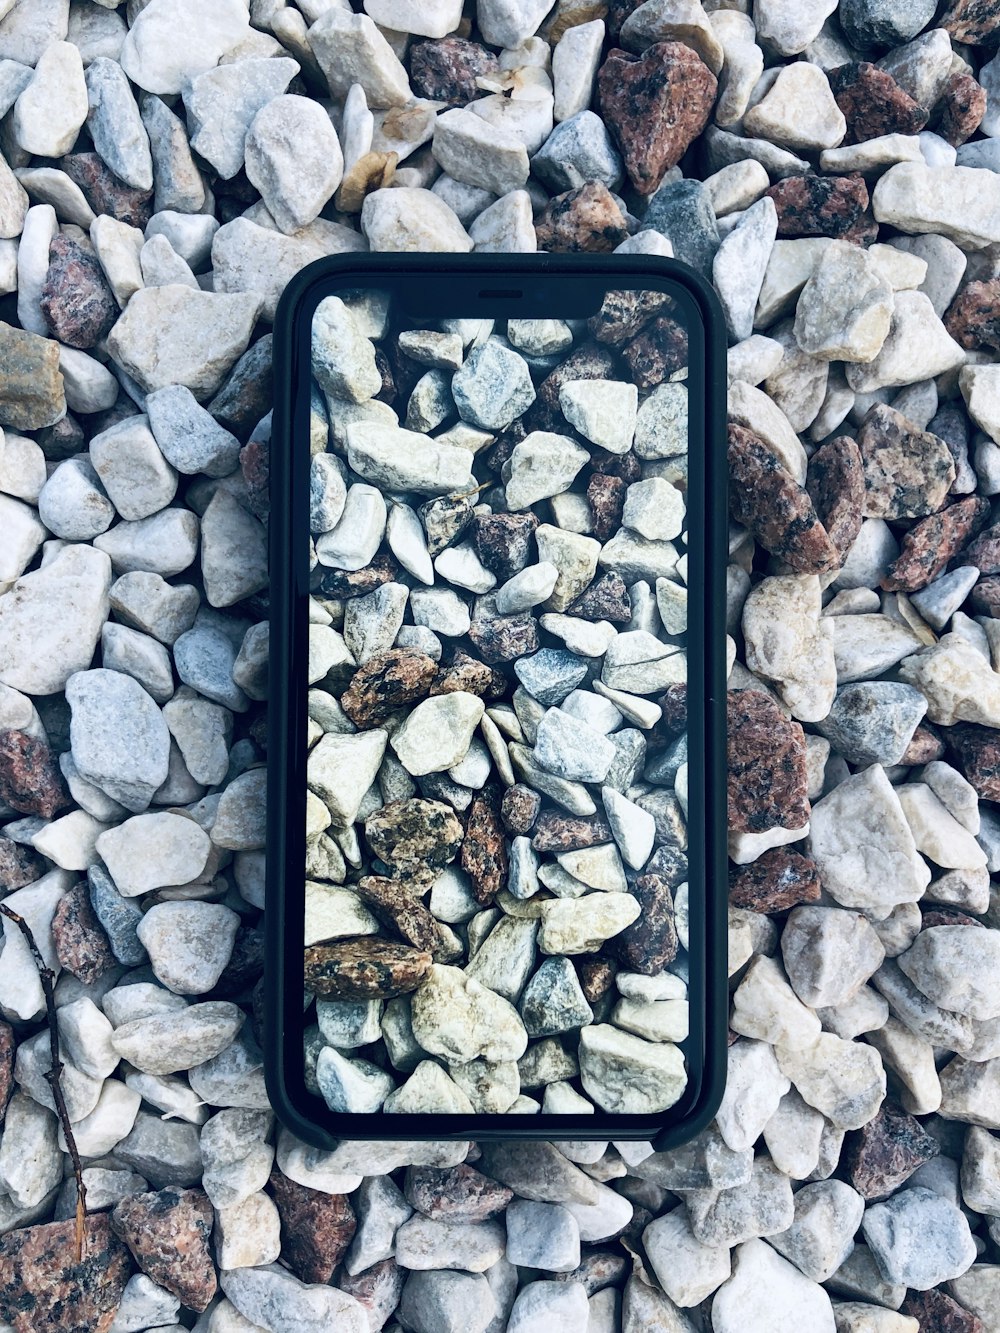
xmin=265 ymin=253 xmax=727 ymax=1150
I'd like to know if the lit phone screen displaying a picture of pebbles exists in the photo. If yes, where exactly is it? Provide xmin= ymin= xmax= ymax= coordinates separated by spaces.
xmin=301 ymin=288 xmax=688 ymax=1116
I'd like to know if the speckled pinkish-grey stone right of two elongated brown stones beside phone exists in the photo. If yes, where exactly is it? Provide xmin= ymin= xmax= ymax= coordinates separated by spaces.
xmin=857 ymin=403 xmax=955 ymax=520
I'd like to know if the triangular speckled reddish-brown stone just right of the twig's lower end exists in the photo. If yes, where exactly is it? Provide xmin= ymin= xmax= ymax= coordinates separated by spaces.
xmin=111 ymin=1186 xmax=217 ymax=1313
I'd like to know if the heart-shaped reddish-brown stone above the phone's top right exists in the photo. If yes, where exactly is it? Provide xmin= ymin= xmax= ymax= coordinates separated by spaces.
xmin=597 ymin=41 xmax=719 ymax=195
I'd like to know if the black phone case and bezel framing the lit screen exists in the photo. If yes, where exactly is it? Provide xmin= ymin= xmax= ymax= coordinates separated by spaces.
xmin=264 ymin=253 xmax=728 ymax=1152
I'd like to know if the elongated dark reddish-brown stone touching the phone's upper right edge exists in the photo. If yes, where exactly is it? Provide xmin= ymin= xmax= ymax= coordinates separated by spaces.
xmin=728 ymin=423 xmax=843 ymax=575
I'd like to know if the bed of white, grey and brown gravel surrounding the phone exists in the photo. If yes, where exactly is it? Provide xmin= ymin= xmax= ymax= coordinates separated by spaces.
xmin=0 ymin=0 xmax=1000 ymax=1333
